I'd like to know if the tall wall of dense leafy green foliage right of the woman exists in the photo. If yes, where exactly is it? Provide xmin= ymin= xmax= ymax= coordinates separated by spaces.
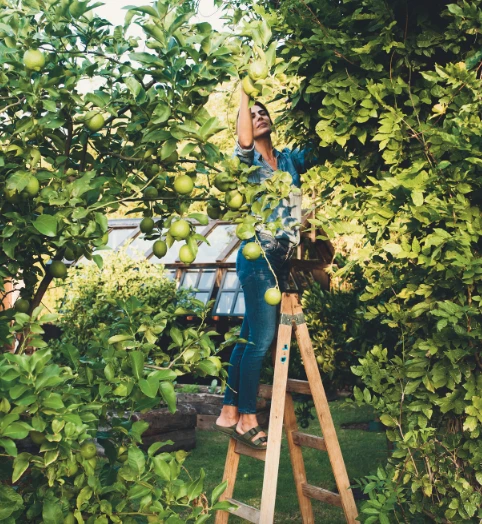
xmin=249 ymin=0 xmax=482 ymax=523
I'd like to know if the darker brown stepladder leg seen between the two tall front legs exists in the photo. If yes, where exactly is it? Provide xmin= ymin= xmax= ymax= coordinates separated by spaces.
xmin=285 ymin=393 xmax=315 ymax=524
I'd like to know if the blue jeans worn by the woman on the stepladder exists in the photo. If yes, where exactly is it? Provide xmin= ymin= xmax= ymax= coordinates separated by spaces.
xmin=224 ymin=233 xmax=293 ymax=414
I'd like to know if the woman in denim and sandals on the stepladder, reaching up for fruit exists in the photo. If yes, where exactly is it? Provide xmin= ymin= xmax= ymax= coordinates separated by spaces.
xmin=215 ymin=84 xmax=309 ymax=449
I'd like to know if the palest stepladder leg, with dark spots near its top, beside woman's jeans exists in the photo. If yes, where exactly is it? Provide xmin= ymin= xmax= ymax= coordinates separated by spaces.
xmin=259 ymin=293 xmax=294 ymax=524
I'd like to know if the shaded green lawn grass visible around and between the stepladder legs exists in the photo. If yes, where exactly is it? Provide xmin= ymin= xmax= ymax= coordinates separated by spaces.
xmin=185 ymin=401 xmax=387 ymax=524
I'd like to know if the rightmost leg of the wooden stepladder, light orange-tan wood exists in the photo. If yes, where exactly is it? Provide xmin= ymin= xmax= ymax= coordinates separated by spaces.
xmin=294 ymin=302 xmax=358 ymax=524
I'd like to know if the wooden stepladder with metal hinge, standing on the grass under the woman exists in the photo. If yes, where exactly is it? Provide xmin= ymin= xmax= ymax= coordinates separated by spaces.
xmin=215 ymin=293 xmax=358 ymax=524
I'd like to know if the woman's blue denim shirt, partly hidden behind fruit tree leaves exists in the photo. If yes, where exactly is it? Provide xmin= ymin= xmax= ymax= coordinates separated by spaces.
xmin=234 ymin=143 xmax=313 ymax=245
